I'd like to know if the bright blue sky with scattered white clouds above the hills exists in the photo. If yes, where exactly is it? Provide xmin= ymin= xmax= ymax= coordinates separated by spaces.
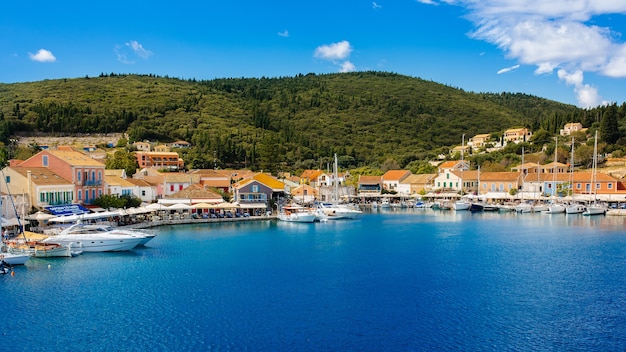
xmin=0 ymin=0 xmax=626 ymax=107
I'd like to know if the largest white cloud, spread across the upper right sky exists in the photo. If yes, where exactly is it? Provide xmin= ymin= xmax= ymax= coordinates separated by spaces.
xmin=417 ymin=0 xmax=626 ymax=107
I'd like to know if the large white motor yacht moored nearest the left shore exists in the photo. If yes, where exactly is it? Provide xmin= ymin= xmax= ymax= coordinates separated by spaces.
xmin=41 ymin=223 xmax=149 ymax=252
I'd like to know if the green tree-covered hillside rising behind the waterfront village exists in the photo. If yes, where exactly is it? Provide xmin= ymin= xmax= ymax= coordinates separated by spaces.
xmin=0 ymin=72 xmax=626 ymax=171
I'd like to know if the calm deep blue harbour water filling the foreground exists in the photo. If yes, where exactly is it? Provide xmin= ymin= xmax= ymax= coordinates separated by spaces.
xmin=0 ymin=210 xmax=626 ymax=351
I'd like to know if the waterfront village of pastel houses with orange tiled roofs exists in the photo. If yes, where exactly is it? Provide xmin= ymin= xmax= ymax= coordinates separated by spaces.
xmin=0 ymin=123 xmax=626 ymax=231
